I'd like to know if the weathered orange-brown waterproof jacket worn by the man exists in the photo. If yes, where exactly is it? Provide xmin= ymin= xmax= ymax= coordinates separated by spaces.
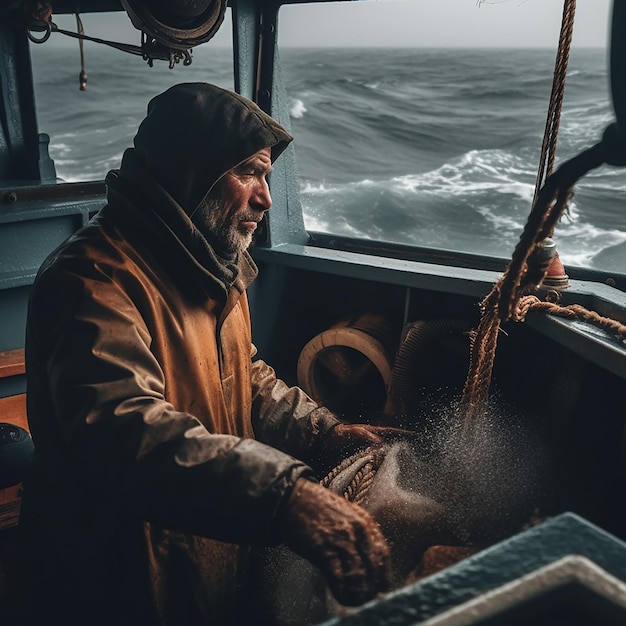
xmin=20 ymin=83 xmax=336 ymax=626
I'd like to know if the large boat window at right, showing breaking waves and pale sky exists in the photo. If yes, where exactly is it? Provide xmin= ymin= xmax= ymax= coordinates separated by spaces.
xmin=278 ymin=0 xmax=626 ymax=273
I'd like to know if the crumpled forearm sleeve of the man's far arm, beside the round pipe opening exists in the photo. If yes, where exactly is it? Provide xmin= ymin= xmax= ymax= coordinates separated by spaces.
xmin=252 ymin=359 xmax=339 ymax=459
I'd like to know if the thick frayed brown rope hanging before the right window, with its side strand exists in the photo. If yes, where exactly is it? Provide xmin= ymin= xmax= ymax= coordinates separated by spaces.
xmin=461 ymin=0 xmax=626 ymax=421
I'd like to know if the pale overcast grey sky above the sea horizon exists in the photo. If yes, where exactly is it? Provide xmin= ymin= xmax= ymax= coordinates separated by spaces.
xmin=53 ymin=0 xmax=613 ymax=48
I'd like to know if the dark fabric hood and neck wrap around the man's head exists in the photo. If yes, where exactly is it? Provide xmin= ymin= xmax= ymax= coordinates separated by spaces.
xmin=106 ymin=83 xmax=292 ymax=297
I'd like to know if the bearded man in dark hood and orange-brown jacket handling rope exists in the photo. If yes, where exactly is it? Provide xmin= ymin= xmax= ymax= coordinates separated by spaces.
xmin=20 ymin=83 xmax=389 ymax=626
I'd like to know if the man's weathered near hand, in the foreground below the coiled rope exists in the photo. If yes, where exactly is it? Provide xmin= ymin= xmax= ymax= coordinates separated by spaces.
xmin=285 ymin=478 xmax=391 ymax=606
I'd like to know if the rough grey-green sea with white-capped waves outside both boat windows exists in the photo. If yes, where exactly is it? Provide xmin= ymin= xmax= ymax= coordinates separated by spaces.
xmin=32 ymin=44 xmax=626 ymax=273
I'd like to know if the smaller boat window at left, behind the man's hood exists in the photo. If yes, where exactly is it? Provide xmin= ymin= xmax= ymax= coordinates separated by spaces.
xmin=30 ymin=9 xmax=233 ymax=182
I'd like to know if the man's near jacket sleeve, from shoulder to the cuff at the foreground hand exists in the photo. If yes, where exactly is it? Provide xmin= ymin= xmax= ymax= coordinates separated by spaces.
xmin=27 ymin=256 xmax=312 ymax=543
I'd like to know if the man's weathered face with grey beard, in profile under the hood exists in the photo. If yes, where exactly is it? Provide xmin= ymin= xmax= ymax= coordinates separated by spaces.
xmin=191 ymin=148 xmax=272 ymax=254
